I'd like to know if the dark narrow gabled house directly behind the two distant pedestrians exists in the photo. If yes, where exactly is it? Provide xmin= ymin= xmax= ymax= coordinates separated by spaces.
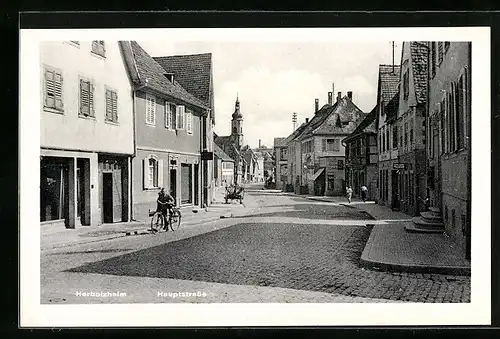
xmin=343 ymin=106 xmax=378 ymax=201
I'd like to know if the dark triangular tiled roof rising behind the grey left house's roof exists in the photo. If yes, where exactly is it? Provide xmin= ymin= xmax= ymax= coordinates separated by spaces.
xmin=153 ymin=53 xmax=214 ymax=121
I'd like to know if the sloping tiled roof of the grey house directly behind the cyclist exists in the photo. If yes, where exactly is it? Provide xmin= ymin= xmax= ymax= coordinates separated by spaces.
xmin=129 ymin=41 xmax=210 ymax=109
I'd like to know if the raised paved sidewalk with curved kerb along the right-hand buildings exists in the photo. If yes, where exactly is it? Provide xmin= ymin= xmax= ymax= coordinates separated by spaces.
xmin=290 ymin=194 xmax=470 ymax=276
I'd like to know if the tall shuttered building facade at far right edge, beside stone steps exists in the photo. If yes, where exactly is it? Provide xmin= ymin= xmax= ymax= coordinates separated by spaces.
xmin=427 ymin=41 xmax=471 ymax=258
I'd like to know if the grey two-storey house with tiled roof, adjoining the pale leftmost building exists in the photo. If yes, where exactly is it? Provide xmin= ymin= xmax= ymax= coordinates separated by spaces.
xmin=121 ymin=41 xmax=210 ymax=220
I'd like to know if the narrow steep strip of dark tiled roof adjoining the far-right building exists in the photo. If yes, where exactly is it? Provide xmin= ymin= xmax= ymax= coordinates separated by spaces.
xmin=410 ymin=41 xmax=428 ymax=104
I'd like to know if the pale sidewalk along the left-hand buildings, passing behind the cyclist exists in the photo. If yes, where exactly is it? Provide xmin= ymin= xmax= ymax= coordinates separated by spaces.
xmin=40 ymin=192 xmax=247 ymax=251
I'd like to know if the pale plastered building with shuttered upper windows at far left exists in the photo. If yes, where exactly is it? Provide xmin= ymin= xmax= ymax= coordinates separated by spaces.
xmin=40 ymin=41 xmax=134 ymax=228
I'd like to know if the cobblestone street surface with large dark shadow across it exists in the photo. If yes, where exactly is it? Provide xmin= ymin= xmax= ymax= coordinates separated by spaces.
xmin=42 ymin=187 xmax=470 ymax=302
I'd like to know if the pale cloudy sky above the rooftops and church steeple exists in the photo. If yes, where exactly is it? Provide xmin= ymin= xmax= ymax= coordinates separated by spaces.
xmin=138 ymin=40 xmax=402 ymax=147
